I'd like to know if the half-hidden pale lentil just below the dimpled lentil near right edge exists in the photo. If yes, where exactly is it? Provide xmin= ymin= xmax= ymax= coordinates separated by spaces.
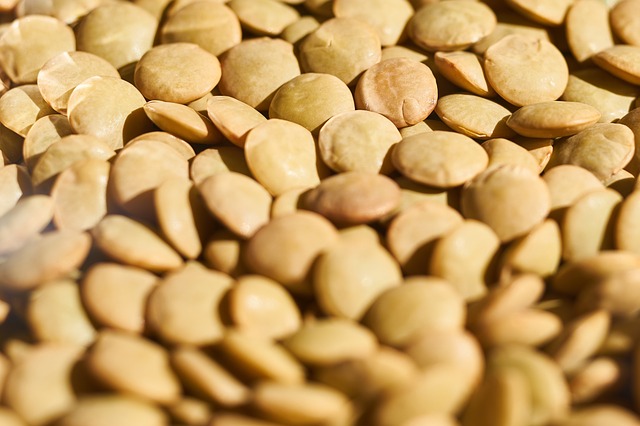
xmin=542 ymin=164 xmax=604 ymax=210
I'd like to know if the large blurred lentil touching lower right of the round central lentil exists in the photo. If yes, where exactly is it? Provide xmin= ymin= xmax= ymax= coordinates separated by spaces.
xmin=363 ymin=277 xmax=466 ymax=347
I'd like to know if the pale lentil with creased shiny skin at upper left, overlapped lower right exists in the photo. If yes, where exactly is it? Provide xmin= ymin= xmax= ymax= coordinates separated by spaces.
xmin=37 ymin=52 xmax=120 ymax=114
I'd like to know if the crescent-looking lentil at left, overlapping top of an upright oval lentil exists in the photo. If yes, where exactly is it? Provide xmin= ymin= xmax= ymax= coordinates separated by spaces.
xmin=32 ymin=135 xmax=115 ymax=190
